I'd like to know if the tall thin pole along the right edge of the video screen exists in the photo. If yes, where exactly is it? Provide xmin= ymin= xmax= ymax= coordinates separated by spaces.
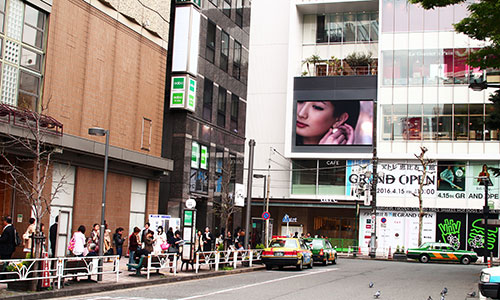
xmin=370 ymin=100 xmax=378 ymax=258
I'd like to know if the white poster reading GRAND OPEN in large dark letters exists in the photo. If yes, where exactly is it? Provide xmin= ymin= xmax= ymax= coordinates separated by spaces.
xmin=377 ymin=162 xmax=436 ymax=198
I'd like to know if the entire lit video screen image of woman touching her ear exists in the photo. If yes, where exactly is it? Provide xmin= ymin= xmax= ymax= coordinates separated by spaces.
xmin=293 ymin=100 xmax=373 ymax=146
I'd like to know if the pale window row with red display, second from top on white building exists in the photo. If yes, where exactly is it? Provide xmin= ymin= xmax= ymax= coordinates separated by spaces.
xmin=381 ymin=48 xmax=483 ymax=86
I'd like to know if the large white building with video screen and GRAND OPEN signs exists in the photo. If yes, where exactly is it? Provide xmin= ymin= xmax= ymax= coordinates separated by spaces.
xmin=247 ymin=0 xmax=500 ymax=256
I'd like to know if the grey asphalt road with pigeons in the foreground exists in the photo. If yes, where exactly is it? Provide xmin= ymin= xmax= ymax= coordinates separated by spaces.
xmin=57 ymin=259 xmax=484 ymax=300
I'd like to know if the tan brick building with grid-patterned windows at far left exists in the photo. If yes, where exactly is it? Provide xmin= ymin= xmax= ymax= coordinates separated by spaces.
xmin=0 ymin=0 xmax=173 ymax=255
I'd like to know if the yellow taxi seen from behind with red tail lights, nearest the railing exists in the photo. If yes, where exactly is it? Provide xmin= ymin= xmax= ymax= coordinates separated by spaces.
xmin=262 ymin=238 xmax=314 ymax=270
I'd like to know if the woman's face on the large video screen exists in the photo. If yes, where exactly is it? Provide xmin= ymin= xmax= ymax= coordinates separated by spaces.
xmin=296 ymin=101 xmax=335 ymax=139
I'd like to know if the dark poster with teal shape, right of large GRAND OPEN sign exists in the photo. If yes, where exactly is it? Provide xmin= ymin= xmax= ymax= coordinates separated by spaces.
xmin=437 ymin=161 xmax=466 ymax=199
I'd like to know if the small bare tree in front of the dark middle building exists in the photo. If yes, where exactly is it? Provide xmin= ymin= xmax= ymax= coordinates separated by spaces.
xmin=213 ymin=158 xmax=241 ymax=243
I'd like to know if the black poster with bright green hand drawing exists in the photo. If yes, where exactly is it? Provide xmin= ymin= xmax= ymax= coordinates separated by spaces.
xmin=436 ymin=213 xmax=467 ymax=250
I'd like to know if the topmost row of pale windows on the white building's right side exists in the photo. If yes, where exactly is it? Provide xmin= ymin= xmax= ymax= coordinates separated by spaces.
xmin=381 ymin=0 xmax=469 ymax=32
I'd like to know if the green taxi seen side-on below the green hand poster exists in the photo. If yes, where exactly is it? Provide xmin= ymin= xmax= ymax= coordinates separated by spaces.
xmin=406 ymin=243 xmax=477 ymax=265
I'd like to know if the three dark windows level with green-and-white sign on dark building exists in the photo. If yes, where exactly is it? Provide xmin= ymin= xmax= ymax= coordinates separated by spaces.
xmin=202 ymin=78 xmax=240 ymax=132
